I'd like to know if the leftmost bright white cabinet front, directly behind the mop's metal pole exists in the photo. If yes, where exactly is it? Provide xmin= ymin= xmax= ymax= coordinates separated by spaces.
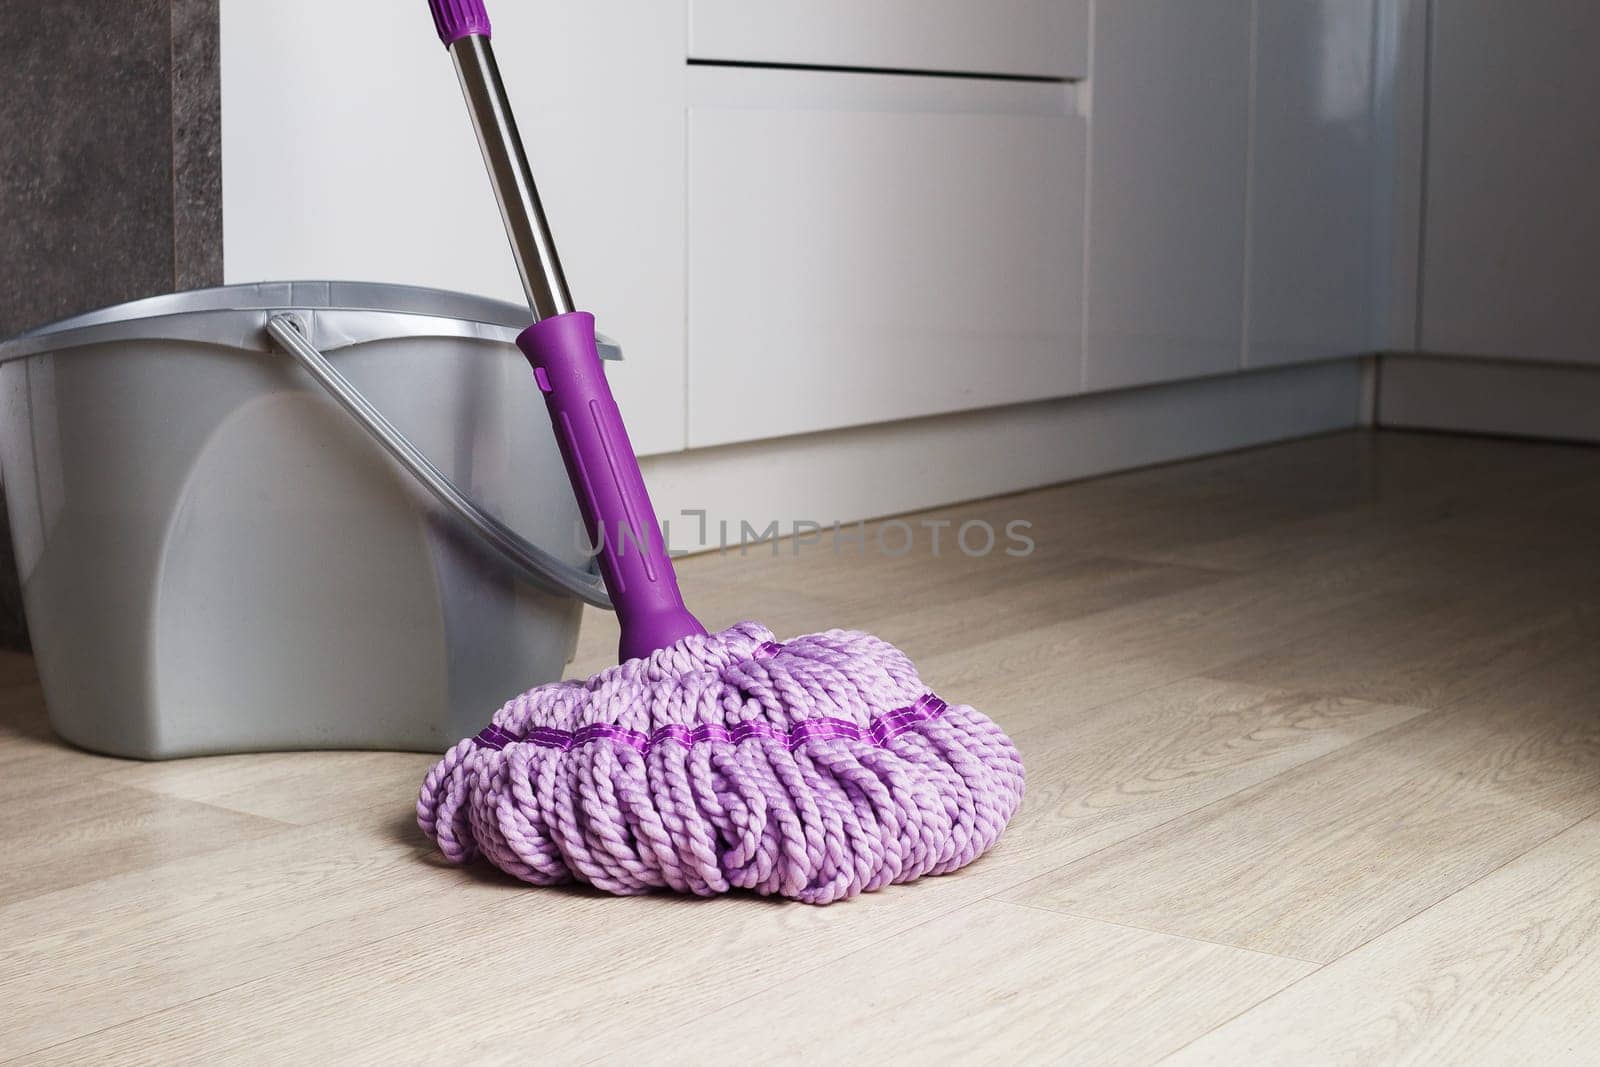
xmin=221 ymin=0 xmax=685 ymax=453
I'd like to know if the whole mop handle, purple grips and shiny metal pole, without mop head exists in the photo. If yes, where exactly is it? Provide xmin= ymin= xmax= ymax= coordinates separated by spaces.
xmin=429 ymin=0 xmax=706 ymax=661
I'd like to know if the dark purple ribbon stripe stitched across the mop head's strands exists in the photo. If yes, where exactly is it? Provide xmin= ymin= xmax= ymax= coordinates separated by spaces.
xmin=472 ymin=693 xmax=949 ymax=755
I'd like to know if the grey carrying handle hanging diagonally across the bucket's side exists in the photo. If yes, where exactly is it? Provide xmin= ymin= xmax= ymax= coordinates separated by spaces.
xmin=267 ymin=314 xmax=611 ymax=609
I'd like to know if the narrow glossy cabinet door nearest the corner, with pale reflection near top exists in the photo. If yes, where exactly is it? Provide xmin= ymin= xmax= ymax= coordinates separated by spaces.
xmin=1245 ymin=0 xmax=1379 ymax=366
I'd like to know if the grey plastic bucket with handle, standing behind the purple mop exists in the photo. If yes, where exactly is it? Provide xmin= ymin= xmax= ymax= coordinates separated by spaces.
xmin=0 ymin=282 xmax=616 ymax=758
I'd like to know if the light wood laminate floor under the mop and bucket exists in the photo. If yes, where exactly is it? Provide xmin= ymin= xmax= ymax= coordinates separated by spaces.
xmin=0 ymin=434 xmax=1600 ymax=1064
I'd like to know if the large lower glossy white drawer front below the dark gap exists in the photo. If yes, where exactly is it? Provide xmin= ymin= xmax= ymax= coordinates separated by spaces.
xmin=688 ymin=67 xmax=1085 ymax=446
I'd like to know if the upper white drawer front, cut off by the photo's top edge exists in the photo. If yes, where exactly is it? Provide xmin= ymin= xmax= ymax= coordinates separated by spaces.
xmin=690 ymin=0 xmax=1090 ymax=78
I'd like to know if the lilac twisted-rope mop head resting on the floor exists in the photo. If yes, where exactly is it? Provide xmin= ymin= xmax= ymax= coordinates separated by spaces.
xmin=416 ymin=622 xmax=1022 ymax=904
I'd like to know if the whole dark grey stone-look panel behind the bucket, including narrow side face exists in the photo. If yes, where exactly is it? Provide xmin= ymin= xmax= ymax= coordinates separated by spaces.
xmin=0 ymin=0 xmax=222 ymax=648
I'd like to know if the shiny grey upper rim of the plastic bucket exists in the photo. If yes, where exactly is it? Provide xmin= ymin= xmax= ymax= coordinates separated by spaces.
xmin=0 ymin=282 xmax=621 ymax=363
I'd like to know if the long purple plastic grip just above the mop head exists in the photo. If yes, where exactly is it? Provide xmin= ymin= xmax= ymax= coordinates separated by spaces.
xmin=517 ymin=312 xmax=706 ymax=661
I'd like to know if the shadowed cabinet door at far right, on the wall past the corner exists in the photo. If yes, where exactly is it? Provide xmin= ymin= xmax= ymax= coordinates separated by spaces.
xmin=1421 ymin=0 xmax=1600 ymax=363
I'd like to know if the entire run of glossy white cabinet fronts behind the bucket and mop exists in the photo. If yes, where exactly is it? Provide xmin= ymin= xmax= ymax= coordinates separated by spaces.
xmin=212 ymin=0 xmax=1386 ymax=476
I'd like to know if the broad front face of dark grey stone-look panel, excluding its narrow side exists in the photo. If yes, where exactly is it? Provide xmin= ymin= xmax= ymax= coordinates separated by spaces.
xmin=0 ymin=0 xmax=173 ymax=334
